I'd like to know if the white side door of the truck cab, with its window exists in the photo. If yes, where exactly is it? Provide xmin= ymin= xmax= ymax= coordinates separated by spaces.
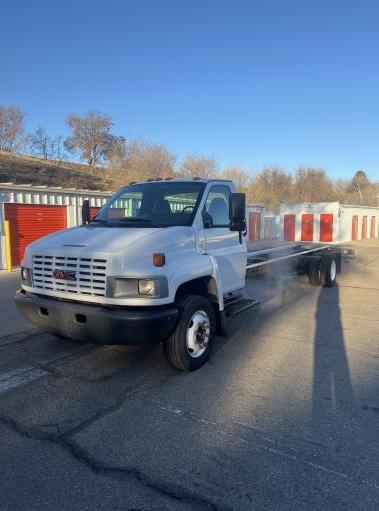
xmin=203 ymin=185 xmax=247 ymax=293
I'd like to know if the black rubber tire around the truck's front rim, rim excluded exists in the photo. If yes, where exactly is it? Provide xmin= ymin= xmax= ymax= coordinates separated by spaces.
xmin=163 ymin=295 xmax=216 ymax=371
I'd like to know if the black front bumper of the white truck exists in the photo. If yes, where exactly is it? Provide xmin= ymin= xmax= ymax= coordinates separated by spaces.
xmin=14 ymin=290 xmax=179 ymax=345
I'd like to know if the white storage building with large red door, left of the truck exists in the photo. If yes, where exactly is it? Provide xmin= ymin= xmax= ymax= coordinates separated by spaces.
xmin=0 ymin=183 xmax=111 ymax=269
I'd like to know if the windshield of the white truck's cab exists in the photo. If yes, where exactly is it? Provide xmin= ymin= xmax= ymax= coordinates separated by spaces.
xmin=92 ymin=181 xmax=205 ymax=227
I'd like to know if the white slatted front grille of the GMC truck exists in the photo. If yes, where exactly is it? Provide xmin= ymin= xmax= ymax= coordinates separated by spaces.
xmin=33 ymin=255 xmax=107 ymax=296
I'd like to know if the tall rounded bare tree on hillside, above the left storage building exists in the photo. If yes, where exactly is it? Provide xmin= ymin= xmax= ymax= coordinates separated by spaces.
xmin=64 ymin=110 xmax=114 ymax=166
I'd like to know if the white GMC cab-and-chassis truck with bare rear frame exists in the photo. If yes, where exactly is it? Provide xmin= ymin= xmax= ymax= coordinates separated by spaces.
xmin=15 ymin=178 xmax=341 ymax=371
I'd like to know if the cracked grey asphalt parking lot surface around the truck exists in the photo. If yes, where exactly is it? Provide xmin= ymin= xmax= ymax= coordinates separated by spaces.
xmin=0 ymin=240 xmax=379 ymax=511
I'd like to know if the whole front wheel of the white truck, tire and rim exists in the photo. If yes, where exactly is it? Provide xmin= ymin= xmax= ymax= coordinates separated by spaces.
xmin=163 ymin=295 xmax=215 ymax=371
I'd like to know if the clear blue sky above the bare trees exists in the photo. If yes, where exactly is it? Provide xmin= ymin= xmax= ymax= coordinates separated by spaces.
xmin=0 ymin=0 xmax=379 ymax=180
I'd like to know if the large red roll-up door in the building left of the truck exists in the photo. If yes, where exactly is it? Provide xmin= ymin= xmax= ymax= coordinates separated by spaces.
xmin=4 ymin=204 xmax=67 ymax=266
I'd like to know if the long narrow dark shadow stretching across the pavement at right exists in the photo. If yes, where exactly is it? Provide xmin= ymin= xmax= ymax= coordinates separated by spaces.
xmin=312 ymin=286 xmax=354 ymax=424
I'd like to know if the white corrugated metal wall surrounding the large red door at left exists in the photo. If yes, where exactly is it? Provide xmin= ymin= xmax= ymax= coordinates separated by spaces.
xmin=0 ymin=183 xmax=111 ymax=269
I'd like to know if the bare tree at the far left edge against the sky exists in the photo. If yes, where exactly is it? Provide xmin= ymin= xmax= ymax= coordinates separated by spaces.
xmin=0 ymin=105 xmax=25 ymax=151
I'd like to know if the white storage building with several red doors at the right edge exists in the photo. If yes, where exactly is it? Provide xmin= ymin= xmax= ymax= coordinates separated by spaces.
xmin=280 ymin=202 xmax=379 ymax=243
